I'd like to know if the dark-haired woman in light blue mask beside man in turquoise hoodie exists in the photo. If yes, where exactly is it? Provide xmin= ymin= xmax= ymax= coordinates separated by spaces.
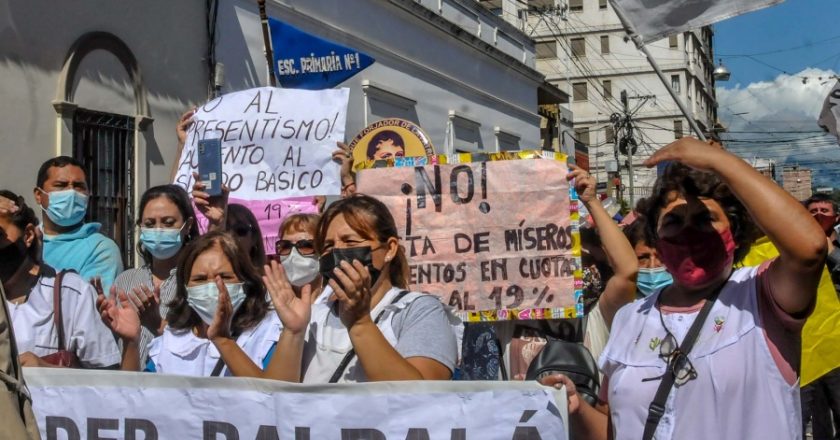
xmin=109 ymin=185 xmax=199 ymax=362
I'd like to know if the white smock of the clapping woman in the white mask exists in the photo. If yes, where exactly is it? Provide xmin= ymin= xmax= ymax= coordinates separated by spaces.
xmin=149 ymin=310 xmax=283 ymax=377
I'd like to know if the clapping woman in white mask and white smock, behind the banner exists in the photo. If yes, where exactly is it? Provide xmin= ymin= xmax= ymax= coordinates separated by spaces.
xmin=102 ymin=231 xmax=280 ymax=376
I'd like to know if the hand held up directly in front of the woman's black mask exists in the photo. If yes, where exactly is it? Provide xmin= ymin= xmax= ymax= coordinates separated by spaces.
xmin=329 ymin=260 xmax=373 ymax=329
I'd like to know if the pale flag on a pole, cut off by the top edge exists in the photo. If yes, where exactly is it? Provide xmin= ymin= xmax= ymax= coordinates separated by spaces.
xmin=612 ymin=0 xmax=784 ymax=43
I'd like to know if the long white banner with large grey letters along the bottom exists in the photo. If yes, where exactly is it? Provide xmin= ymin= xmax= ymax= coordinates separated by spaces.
xmin=24 ymin=368 xmax=568 ymax=440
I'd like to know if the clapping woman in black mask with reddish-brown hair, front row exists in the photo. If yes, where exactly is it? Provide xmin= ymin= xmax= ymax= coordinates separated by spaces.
xmin=263 ymin=195 xmax=457 ymax=383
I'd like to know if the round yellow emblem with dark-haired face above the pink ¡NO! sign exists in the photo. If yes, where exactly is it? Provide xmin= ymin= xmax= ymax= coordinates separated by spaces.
xmin=349 ymin=118 xmax=435 ymax=170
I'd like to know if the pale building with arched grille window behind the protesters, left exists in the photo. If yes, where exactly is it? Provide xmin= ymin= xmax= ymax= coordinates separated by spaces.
xmin=0 ymin=0 xmax=568 ymax=264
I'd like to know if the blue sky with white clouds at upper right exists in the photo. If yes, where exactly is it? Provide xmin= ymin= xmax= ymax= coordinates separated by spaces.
xmin=714 ymin=0 xmax=840 ymax=188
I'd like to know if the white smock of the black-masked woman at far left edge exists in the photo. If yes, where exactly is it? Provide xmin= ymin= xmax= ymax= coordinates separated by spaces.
xmin=7 ymin=270 xmax=121 ymax=368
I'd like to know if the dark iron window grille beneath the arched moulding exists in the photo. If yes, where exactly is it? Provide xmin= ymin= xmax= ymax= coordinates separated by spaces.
xmin=73 ymin=109 xmax=134 ymax=267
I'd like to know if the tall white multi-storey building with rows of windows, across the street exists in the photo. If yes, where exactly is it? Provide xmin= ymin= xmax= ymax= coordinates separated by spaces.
xmin=481 ymin=0 xmax=718 ymax=202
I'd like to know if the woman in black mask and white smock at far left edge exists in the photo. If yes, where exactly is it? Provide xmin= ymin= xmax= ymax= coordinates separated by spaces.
xmin=0 ymin=190 xmax=120 ymax=368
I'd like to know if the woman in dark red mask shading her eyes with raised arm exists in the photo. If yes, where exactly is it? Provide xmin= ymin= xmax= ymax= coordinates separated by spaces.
xmin=543 ymin=138 xmax=826 ymax=440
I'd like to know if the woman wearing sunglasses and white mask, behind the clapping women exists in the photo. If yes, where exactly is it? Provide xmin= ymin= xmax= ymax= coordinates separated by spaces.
xmin=275 ymin=214 xmax=323 ymax=301
